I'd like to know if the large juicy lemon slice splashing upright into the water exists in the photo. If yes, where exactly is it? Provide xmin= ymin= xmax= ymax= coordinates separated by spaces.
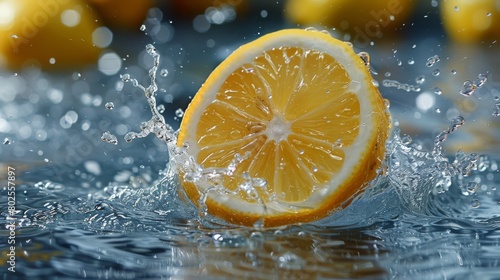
xmin=178 ymin=29 xmax=390 ymax=226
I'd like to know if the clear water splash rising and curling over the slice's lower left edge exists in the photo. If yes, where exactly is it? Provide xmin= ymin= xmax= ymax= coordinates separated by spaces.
xmin=121 ymin=44 xmax=267 ymax=223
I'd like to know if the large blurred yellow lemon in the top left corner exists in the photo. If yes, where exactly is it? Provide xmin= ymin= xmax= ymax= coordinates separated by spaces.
xmin=0 ymin=0 xmax=100 ymax=69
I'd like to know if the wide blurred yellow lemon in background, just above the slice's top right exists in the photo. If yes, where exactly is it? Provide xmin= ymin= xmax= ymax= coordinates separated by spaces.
xmin=285 ymin=0 xmax=417 ymax=46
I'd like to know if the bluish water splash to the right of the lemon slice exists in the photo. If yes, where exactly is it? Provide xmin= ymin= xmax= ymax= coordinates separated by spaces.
xmin=387 ymin=116 xmax=488 ymax=213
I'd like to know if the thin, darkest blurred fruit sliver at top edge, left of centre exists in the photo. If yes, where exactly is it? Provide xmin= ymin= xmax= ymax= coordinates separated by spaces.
xmin=169 ymin=0 xmax=249 ymax=18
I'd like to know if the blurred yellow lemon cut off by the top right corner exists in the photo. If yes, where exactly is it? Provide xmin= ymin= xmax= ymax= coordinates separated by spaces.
xmin=440 ymin=0 xmax=500 ymax=43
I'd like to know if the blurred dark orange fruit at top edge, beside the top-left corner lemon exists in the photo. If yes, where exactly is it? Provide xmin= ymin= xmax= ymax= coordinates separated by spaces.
xmin=87 ymin=0 xmax=154 ymax=30
